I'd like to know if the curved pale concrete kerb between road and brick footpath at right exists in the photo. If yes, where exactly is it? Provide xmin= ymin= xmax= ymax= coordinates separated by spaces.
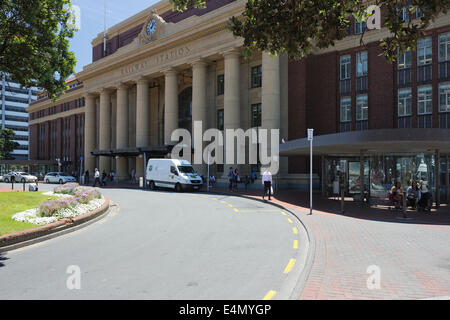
xmin=207 ymin=191 xmax=316 ymax=300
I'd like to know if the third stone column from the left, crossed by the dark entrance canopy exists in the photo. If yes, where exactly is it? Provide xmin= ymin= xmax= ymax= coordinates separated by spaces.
xmin=116 ymin=84 xmax=128 ymax=180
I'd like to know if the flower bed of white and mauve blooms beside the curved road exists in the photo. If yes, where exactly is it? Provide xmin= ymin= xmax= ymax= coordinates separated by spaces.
xmin=12 ymin=183 xmax=105 ymax=225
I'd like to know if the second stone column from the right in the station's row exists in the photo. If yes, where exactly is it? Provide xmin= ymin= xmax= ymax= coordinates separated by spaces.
xmin=223 ymin=50 xmax=241 ymax=175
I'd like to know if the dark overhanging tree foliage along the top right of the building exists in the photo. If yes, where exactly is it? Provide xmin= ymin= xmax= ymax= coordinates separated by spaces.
xmin=170 ymin=0 xmax=450 ymax=61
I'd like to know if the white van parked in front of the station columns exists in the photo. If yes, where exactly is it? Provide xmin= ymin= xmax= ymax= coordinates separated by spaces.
xmin=146 ymin=159 xmax=203 ymax=192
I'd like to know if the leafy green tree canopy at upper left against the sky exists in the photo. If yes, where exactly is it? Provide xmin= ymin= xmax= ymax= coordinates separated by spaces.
xmin=0 ymin=0 xmax=76 ymax=98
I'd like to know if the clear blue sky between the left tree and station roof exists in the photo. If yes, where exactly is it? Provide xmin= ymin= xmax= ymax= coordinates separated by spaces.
xmin=70 ymin=0 xmax=158 ymax=73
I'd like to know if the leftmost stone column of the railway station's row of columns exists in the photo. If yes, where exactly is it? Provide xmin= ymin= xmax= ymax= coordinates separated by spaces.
xmin=84 ymin=94 xmax=96 ymax=175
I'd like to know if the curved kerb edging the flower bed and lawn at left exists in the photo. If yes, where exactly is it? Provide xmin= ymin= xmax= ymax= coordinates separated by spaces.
xmin=0 ymin=198 xmax=110 ymax=253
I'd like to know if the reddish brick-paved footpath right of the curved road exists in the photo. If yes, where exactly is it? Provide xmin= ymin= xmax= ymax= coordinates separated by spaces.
xmin=215 ymin=189 xmax=450 ymax=300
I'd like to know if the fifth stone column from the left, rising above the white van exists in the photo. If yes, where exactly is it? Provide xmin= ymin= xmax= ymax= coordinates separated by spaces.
xmin=164 ymin=69 xmax=178 ymax=145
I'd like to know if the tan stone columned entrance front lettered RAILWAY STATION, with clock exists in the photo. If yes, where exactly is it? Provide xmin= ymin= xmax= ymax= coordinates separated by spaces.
xmin=78 ymin=3 xmax=287 ymax=180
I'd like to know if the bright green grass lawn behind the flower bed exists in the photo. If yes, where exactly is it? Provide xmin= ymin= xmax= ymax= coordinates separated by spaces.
xmin=0 ymin=192 xmax=55 ymax=236
